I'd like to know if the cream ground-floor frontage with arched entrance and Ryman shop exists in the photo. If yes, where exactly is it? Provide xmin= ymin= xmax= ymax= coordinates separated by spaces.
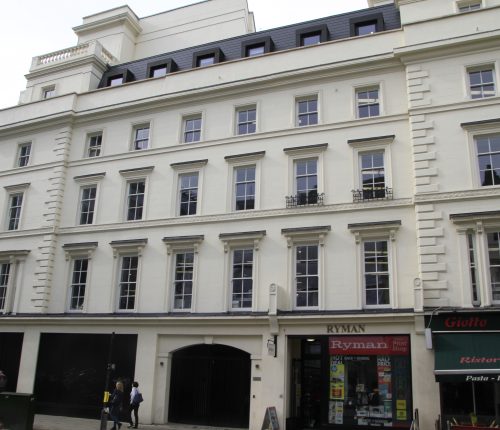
xmin=0 ymin=313 xmax=439 ymax=429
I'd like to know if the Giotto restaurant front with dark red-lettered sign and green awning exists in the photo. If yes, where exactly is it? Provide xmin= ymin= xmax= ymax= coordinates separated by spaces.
xmin=426 ymin=311 xmax=500 ymax=428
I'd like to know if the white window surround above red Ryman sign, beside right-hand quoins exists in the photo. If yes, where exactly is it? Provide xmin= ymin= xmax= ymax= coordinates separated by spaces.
xmin=348 ymin=221 xmax=401 ymax=309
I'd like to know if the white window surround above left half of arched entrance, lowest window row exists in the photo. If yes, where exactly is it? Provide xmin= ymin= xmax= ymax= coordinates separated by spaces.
xmin=163 ymin=235 xmax=204 ymax=313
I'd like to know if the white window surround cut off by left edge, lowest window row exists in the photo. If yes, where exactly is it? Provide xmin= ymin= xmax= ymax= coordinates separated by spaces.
xmin=0 ymin=250 xmax=30 ymax=314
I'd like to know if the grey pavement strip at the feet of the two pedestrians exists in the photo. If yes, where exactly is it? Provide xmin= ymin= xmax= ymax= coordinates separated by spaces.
xmin=33 ymin=415 xmax=242 ymax=430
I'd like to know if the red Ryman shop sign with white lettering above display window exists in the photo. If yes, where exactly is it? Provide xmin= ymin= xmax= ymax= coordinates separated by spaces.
xmin=328 ymin=336 xmax=410 ymax=355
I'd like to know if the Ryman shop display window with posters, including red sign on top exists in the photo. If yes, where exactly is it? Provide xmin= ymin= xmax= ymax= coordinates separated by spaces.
xmin=328 ymin=336 xmax=412 ymax=428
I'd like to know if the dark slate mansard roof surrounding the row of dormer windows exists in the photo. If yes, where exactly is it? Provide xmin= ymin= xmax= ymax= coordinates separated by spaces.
xmin=99 ymin=4 xmax=401 ymax=88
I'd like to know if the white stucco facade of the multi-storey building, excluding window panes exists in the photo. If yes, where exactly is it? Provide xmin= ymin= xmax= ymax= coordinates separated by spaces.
xmin=0 ymin=0 xmax=500 ymax=430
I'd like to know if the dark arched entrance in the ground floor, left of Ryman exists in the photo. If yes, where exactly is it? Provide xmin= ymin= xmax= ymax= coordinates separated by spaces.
xmin=169 ymin=345 xmax=250 ymax=428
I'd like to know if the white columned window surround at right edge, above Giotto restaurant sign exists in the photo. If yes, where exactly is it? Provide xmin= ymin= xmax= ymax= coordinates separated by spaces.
xmin=450 ymin=215 xmax=500 ymax=308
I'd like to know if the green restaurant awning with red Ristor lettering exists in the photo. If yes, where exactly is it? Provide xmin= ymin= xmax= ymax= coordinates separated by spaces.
xmin=433 ymin=333 xmax=500 ymax=382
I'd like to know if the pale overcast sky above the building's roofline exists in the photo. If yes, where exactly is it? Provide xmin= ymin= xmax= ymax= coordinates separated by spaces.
xmin=0 ymin=0 xmax=368 ymax=109
